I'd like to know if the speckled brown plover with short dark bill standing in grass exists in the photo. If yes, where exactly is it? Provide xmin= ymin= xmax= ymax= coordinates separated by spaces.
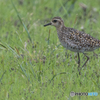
xmin=44 ymin=17 xmax=100 ymax=75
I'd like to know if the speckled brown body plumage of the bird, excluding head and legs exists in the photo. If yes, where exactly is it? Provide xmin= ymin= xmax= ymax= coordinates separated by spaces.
xmin=57 ymin=26 xmax=100 ymax=52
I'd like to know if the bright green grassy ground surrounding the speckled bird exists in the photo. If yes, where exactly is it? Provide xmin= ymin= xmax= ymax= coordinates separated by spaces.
xmin=0 ymin=0 xmax=100 ymax=100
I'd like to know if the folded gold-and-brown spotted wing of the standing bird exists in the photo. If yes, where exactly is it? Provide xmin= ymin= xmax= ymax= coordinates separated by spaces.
xmin=66 ymin=28 xmax=100 ymax=47
